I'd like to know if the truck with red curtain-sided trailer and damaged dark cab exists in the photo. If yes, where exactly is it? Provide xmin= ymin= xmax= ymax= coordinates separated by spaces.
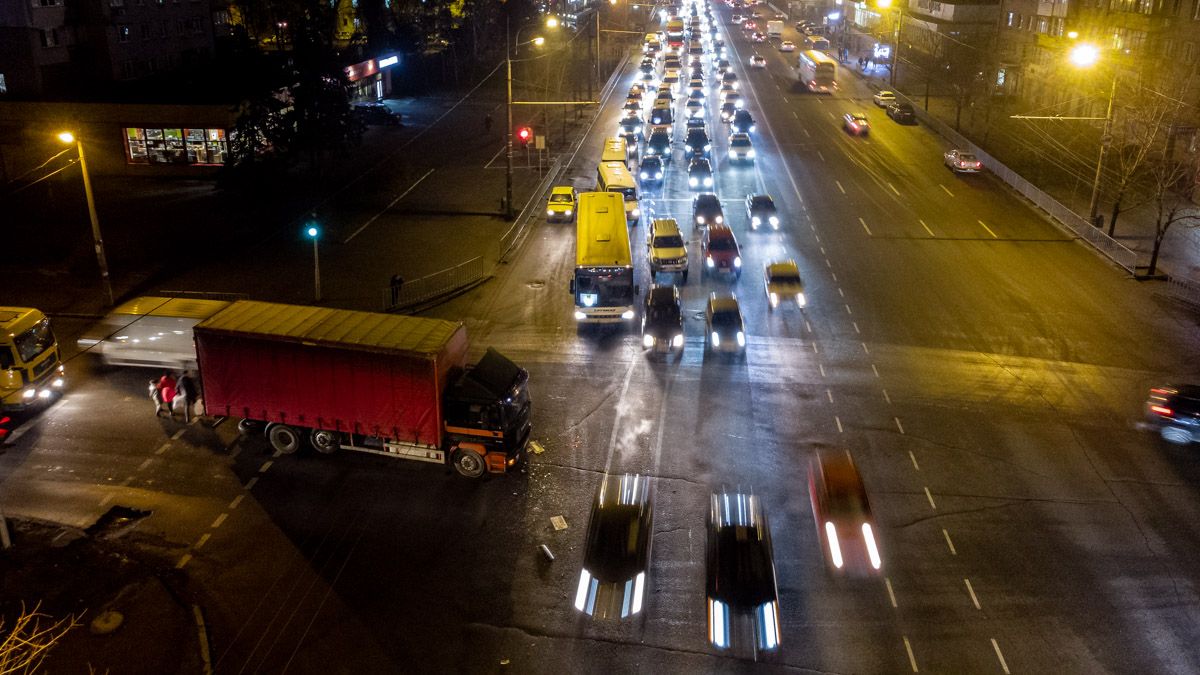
xmin=193 ymin=300 xmax=530 ymax=478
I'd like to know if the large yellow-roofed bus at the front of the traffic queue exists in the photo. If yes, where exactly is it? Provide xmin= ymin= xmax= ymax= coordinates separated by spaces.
xmin=571 ymin=192 xmax=637 ymax=323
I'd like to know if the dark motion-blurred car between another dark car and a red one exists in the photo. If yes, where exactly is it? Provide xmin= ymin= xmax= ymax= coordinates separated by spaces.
xmin=704 ymin=492 xmax=780 ymax=651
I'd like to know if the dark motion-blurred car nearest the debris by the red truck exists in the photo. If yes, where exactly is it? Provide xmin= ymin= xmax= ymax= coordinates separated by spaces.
xmin=575 ymin=473 xmax=654 ymax=619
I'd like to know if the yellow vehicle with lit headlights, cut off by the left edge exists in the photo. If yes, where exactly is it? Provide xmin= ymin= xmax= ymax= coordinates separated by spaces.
xmin=0 ymin=307 xmax=66 ymax=411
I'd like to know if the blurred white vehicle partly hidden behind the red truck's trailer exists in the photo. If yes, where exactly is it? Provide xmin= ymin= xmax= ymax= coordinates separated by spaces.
xmin=76 ymin=295 xmax=229 ymax=370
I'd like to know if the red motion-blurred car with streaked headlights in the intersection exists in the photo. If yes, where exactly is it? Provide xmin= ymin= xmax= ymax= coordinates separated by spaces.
xmin=809 ymin=450 xmax=883 ymax=577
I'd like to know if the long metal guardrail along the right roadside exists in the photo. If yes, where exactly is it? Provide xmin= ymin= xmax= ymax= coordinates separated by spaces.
xmin=896 ymin=92 xmax=1138 ymax=274
